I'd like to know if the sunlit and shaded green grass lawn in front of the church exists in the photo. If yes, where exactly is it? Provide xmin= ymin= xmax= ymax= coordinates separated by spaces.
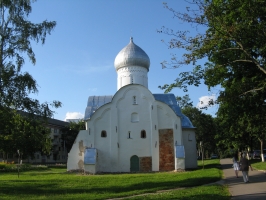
xmin=0 ymin=159 xmax=230 ymax=200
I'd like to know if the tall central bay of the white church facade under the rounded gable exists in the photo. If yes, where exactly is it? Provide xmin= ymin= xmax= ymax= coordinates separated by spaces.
xmin=115 ymin=85 xmax=154 ymax=172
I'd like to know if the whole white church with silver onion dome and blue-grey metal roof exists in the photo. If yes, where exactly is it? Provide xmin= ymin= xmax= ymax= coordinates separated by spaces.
xmin=67 ymin=38 xmax=197 ymax=174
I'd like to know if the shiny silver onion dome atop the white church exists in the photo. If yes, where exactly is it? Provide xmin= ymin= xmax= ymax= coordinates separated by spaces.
xmin=115 ymin=37 xmax=150 ymax=71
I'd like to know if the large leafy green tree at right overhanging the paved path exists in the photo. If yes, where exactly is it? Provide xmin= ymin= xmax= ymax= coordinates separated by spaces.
xmin=160 ymin=0 xmax=266 ymax=160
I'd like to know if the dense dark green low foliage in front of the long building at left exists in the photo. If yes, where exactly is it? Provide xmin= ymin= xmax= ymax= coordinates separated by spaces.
xmin=0 ymin=110 xmax=52 ymax=158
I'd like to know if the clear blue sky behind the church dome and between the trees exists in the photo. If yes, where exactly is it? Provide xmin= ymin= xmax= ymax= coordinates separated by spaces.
xmin=23 ymin=0 xmax=217 ymax=120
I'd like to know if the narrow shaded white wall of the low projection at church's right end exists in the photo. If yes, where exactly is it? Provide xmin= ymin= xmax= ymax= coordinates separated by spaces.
xmin=182 ymin=128 xmax=198 ymax=169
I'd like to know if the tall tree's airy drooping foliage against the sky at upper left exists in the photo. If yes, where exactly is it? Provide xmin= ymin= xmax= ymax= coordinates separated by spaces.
xmin=0 ymin=0 xmax=61 ymax=117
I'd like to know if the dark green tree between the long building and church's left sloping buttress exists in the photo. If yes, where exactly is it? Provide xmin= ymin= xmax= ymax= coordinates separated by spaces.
xmin=61 ymin=120 xmax=85 ymax=153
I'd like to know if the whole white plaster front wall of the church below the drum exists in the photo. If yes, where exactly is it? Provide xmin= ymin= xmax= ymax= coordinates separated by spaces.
xmin=67 ymin=84 xmax=196 ymax=172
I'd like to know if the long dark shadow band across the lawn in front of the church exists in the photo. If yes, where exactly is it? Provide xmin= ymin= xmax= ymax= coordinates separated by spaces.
xmin=0 ymin=176 xmax=221 ymax=199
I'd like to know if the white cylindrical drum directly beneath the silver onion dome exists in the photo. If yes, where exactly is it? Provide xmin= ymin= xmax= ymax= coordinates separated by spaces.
xmin=117 ymin=66 xmax=148 ymax=90
